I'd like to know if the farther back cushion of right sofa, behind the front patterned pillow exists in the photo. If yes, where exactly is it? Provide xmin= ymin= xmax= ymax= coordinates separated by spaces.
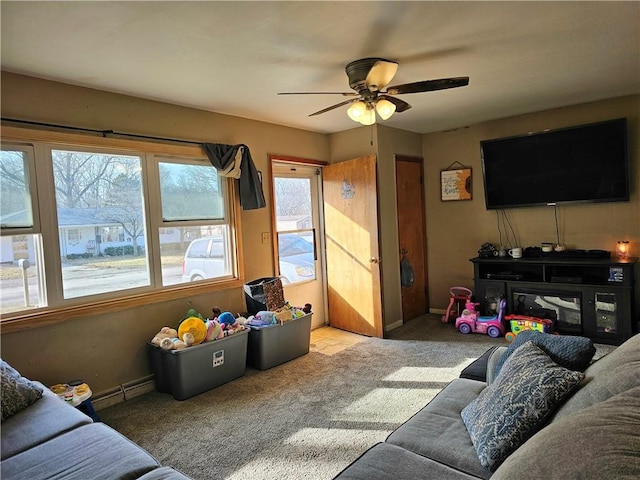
xmin=554 ymin=333 xmax=640 ymax=420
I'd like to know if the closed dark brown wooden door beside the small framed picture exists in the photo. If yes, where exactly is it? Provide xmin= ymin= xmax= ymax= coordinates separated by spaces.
xmin=396 ymin=155 xmax=429 ymax=321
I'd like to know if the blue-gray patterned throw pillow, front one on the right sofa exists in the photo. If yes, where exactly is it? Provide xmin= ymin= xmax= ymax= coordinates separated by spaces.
xmin=461 ymin=342 xmax=584 ymax=471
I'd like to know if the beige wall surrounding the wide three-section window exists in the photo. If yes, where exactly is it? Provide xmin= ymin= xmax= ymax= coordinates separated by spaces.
xmin=0 ymin=72 xmax=329 ymax=392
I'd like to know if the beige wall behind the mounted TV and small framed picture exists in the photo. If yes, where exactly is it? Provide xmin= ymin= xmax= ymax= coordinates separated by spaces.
xmin=422 ymin=95 xmax=640 ymax=309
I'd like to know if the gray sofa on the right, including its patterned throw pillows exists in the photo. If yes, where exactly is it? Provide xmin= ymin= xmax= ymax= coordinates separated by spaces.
xmin=335 ymin=332 xmax=640 ymax=480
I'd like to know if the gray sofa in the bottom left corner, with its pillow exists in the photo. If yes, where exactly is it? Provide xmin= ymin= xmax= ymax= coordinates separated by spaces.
xmin=0 ymin=362 xmax=188 ymax=480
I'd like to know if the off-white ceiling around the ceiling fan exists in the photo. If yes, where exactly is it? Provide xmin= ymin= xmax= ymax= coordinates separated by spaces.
xmin=0 ymin=0 xmax=640 ymax=133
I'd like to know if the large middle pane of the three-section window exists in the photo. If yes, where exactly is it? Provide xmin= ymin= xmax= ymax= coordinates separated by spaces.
xmin=51 ymin=150 xmax=151 ymax=299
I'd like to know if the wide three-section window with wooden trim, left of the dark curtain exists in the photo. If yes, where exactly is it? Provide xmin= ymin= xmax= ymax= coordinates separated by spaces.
xmin=0 ymin=131 xmax=239 ymax=321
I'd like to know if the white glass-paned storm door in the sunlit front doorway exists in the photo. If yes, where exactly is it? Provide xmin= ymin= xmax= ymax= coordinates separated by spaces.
xmin=272 ymin=161 xmax=328 ymax=328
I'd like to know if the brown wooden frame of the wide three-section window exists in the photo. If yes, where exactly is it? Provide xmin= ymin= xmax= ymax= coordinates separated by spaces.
xmin=0 ymin=126 xmax=244 ymax=332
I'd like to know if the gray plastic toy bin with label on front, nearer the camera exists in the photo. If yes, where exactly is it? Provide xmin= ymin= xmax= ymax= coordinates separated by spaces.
xmin=147 ymin=330 xmax=249 ymax=400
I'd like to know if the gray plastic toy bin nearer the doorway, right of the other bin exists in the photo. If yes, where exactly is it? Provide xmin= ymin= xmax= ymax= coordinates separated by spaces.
xmin=247 ymin=313 xmax=313 ymax=370
